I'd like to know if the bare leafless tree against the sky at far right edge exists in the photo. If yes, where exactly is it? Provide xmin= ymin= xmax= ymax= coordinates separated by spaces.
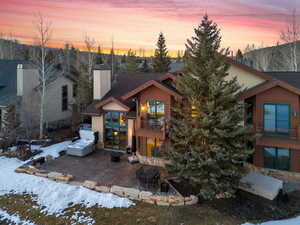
xmin=280 ymin=10 xmax=300 ymax=71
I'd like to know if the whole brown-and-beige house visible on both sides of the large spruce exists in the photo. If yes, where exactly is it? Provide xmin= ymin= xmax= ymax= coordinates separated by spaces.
xmin=86 ymin=58 xmax=300 ymax=172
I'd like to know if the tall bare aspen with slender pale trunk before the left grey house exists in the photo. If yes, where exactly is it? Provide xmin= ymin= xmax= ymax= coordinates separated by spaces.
xmin=35 ymin=13 xmax=54 ymax=138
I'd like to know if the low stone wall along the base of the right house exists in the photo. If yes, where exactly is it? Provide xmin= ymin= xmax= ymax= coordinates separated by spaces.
xmin=245 ymin=163 xmax=300 ymax=183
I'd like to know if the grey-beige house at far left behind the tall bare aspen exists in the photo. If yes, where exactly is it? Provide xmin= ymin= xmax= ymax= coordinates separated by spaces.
xmin=0 ymin=60 xmax=74 ymax=134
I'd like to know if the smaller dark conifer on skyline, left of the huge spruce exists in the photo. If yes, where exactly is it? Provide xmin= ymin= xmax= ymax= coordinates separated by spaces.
xmin=153 ymin=33 xmax=171 ymax=72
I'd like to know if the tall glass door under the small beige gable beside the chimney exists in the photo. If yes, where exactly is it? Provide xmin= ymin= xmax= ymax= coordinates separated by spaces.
xmin=104 ymin=112 xmax=127 ymax=150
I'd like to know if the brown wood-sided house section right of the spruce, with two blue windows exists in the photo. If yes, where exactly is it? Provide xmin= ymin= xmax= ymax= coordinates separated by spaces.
xmin=240 ymin=72 xmax=300 ymax=172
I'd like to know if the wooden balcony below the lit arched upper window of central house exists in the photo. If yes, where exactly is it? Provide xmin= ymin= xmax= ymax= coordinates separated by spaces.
xmin=136 ymin=117 xmax=166 ymax=140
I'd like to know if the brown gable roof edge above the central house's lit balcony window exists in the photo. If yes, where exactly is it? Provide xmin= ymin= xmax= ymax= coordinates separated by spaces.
xmin=122 ymin=80 xmax=181 ymax=100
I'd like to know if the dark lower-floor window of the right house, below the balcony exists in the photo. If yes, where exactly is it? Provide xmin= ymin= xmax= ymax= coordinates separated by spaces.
xmin=264 ymin=147 xmax=291 ymax=170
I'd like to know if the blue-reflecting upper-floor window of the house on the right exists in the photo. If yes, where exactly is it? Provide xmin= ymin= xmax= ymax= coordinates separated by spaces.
xmin=264 ymin=104 xmax=290 ymax=133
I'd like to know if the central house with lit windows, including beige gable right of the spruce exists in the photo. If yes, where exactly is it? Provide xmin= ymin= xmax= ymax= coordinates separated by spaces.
xmin=85 ymin=59 xmax=270 ymax=165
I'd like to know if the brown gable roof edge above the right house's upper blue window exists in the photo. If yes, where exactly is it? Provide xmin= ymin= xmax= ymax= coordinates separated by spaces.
xmin=238 ymin=80 xmax=300 ymax=100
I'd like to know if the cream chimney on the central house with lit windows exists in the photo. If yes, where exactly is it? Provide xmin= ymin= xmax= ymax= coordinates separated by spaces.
xmin=93 ymin=65 xmax=111 ymax=100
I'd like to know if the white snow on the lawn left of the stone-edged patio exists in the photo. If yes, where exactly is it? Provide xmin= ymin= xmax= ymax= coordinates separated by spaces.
xmin=0 ymin=141 xmax=134 ymax=223
